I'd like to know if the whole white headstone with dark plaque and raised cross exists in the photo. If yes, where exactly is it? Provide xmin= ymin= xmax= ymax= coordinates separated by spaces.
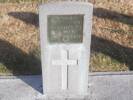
xmin=39 ymin=2 xmax=93 ymax=97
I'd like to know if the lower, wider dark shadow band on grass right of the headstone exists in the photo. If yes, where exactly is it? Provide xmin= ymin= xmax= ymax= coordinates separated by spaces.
xmin=91 ymin=35 xmax=133 ymax=71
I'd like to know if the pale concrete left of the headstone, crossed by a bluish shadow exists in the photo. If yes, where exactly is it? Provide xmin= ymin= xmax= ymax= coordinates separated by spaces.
xmin=0 ymin=76 xmax=42 ymax=100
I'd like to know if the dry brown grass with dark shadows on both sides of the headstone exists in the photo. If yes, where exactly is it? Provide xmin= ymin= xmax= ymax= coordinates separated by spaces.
xmin=0 ymin=0 xmax=133 ymax=75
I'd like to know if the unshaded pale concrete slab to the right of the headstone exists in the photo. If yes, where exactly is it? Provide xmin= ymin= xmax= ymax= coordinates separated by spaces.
xmin=89 ymin=72 xmax=133 ymax=100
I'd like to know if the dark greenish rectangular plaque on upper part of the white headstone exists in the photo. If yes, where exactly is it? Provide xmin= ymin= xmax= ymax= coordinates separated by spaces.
xmin=48 ymin=15 xmax=84 ymax=43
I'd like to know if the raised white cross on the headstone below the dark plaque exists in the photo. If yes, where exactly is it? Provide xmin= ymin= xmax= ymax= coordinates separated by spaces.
xmin=52 ymin=50 xmax=78 ymax=90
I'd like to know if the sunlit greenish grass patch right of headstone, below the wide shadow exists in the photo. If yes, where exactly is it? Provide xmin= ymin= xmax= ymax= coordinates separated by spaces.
xmin=90 ymin=53 xmax=128 ymax=72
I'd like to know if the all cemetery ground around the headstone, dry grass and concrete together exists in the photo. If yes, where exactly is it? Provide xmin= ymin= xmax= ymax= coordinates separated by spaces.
xmin=0 ymin=0 xmax=133 ymax=100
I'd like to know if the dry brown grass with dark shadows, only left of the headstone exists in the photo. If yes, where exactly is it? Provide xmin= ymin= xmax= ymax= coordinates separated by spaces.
xmin=0 ymin=3 xmax=41 ymax=75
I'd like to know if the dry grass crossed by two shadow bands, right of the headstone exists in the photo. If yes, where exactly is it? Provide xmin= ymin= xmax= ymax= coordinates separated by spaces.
xmin=90 ymin=0 xmax=133 ymax=72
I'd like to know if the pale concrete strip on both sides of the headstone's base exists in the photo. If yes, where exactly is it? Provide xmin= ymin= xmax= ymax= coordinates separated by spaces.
xmin=0 ymin=73 xmax=133 ymax=100
